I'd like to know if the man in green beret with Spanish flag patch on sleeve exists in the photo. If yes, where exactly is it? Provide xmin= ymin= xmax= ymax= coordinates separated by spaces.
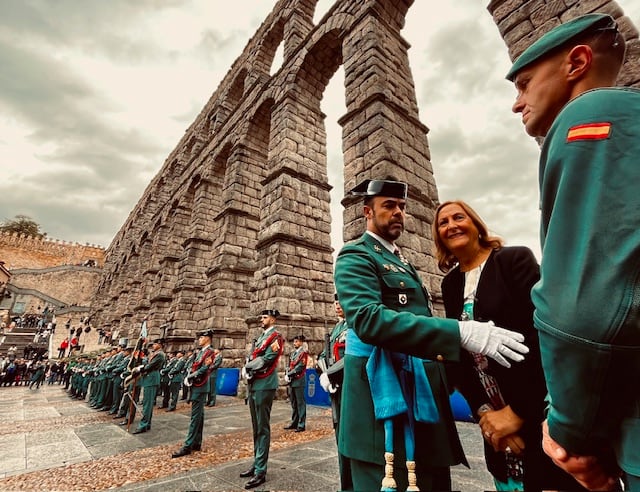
xmin=507 ymin=14 xmax=640 ymax=490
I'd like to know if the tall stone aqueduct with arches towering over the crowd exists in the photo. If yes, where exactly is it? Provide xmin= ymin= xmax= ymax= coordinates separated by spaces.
xmin=92 ymin=0 xmax=640 ymax=363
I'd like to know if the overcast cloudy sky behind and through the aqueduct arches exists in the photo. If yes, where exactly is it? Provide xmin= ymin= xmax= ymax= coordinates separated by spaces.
xmin=0 ymin=0 xmax=640 ymax=262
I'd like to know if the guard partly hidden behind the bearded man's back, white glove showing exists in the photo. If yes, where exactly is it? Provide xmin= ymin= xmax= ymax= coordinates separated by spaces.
xmin=317 ymin=293 xmax=353 ymax=490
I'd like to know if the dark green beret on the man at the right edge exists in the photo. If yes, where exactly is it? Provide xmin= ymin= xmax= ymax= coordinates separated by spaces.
xmin=506 ymin=14 xmax=618 ymax=81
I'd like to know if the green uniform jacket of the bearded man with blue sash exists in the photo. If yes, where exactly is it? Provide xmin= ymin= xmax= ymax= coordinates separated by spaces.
xmin=335 ymin=233 xmax=466 ymax=466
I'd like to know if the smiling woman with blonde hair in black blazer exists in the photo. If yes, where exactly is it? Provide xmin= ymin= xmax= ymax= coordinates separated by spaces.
xmin=432 ymin=200 xmax=584 ymax=491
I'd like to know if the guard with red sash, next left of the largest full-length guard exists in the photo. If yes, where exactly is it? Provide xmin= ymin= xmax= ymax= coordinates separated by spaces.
xmin=171 ymin=330 xmax=214 ymax=458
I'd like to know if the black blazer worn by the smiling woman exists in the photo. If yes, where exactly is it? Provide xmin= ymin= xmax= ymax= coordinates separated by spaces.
xmin=442 ymin=246 xmax=583 ymax=490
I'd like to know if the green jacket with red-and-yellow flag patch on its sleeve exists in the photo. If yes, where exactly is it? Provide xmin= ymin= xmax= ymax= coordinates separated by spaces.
xmin=532 ymin=88 xmax=640 ymax=475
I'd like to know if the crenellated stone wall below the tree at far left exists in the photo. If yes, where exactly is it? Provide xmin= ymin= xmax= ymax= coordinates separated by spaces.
xmin=0 ymin=232 xmax=105 ymax=270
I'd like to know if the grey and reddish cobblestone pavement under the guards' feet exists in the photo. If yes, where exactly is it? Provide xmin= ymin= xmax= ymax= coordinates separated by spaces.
xmin=0 ymin=385 xmax=492 ymax=492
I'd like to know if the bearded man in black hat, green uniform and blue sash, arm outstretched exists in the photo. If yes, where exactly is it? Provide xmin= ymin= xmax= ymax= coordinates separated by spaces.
xmin=335 ymin=179 xmax=528 ymax=490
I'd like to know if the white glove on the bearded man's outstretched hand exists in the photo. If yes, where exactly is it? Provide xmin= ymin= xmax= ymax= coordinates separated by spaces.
xmin=458 ymin=320 xmax=529 ymax=367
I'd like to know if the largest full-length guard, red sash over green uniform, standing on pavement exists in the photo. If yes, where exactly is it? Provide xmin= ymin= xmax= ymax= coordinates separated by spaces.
xmin=240 ymin=309 xmax=284 ymax=489
